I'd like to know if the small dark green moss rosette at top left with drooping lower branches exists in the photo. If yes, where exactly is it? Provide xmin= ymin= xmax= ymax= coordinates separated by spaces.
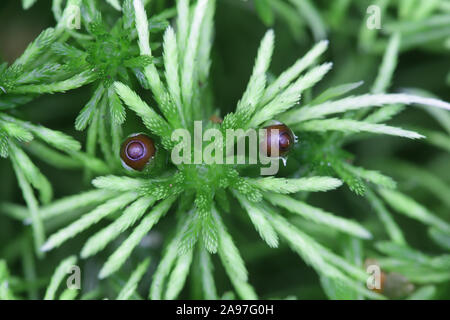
xmin=47 ymin=0 xmax=170 ymax=168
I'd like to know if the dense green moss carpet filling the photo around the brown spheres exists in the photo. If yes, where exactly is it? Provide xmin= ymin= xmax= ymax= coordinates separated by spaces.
xmin=0 ymin=0 xmax=450 ymax=300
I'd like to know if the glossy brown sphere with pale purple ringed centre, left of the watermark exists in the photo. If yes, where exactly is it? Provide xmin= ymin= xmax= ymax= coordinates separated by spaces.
xmin=120 ymin=133 xmax=156 ymax=171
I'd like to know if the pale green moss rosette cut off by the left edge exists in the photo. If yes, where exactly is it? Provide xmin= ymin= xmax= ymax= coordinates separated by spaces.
xmin=0 ymin=1 xmax=160 ymax=255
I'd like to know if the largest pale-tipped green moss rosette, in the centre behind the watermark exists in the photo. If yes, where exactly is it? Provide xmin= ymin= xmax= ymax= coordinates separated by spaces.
xmin=37 ymin=0 xmax=450 ymax=299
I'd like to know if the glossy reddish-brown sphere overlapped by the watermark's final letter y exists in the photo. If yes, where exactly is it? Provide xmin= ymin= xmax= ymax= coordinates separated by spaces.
xmin=261 ymin=123 xmax=295 ymax=157
